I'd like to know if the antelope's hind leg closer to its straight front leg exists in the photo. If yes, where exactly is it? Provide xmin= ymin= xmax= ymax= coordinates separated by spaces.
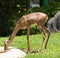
xmin=32 ymin=26 xmax=46 ymax=53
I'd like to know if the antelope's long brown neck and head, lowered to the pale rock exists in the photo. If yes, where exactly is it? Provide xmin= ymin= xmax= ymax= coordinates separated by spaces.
xmin=4 ymin=23 xmax=20 ymax=50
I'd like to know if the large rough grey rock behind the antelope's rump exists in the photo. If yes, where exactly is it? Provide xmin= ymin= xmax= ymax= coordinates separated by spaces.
xmin=47 ymin=11 xmax=60 ymax=32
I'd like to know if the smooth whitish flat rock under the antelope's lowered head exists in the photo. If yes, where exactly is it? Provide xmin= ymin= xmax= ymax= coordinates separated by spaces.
xmin=0 ymin=47 xmax=26 ymax=58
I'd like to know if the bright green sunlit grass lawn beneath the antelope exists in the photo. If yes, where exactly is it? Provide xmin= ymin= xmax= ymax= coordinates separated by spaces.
xmin=0 ymin=33 xmax=60 ymax=58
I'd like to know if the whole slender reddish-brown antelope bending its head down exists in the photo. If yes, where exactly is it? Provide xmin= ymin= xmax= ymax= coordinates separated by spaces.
xmin=4 ymin=12 xmax=50 ymax=52
